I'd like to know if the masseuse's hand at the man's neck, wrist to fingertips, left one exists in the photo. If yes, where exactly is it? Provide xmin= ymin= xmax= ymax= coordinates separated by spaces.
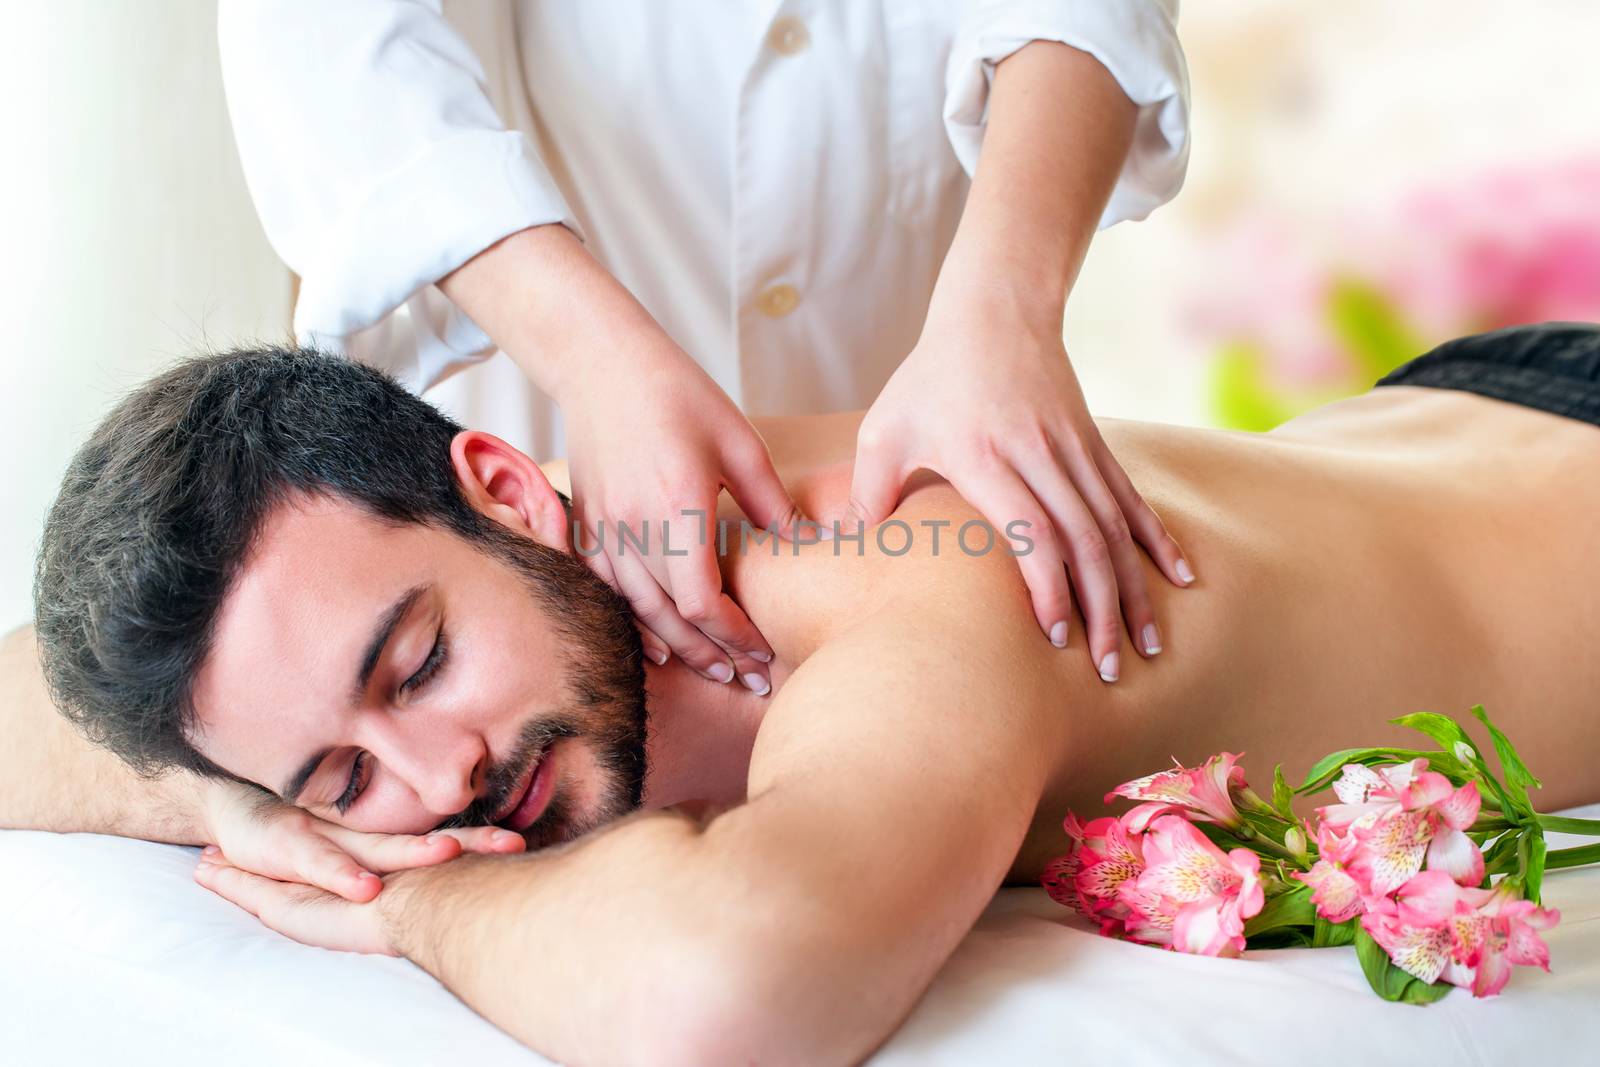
xmin=562 ymin=337 xmax=805 ymax=694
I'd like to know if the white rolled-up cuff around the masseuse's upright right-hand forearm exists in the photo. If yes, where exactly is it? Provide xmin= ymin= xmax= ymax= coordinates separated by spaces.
xmin=944 ymin=0 xmax=1189 ymax=229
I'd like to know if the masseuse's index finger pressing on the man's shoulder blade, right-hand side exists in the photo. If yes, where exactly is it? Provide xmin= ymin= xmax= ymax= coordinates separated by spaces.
xmin=939 ymin=463 xmax=1072 ymax=648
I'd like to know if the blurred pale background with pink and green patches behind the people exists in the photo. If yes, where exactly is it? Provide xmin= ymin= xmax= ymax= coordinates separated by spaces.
xmin=0 ymin=0 xmax=1600 ymax=629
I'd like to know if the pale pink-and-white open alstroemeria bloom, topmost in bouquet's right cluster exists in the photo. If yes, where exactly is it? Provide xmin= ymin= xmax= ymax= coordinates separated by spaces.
xmin=1317 ymin=758 xmax=1483 ymax=896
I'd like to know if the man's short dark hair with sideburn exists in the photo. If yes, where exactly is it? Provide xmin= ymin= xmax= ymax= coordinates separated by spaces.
xmin=34 ymin=349 xmax=601 ymax=777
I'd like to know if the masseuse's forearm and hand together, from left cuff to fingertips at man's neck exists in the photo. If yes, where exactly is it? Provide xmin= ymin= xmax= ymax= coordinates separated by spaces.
xmin=440 ymin=226 xmax=800 ymax=693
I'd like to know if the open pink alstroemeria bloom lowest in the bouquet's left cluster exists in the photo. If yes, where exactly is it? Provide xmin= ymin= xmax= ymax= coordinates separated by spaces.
xmin=1118 ymin=814 xmax=1264 ymax=957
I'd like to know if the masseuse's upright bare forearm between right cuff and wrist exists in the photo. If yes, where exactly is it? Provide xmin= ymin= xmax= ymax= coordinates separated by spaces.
xmin=934 ymin=42 xmax=1138 ymax=317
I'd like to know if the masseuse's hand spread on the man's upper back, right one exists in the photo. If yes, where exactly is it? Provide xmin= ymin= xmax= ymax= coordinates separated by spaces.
xmin=848 ymin=285 xmax=1194 ymax=681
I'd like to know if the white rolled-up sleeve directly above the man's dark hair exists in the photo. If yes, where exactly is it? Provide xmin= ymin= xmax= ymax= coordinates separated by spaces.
xmin=218 ymin=0 xmax=578 ymax=356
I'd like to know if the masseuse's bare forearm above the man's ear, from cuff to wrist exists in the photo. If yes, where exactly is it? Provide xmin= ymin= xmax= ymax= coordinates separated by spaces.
xmin=438 ymin=224 xmax=677 ymax=403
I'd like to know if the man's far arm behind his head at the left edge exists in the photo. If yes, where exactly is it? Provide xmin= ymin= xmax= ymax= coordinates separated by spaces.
xmin=0 ymin=627 xmax=206 ymax=845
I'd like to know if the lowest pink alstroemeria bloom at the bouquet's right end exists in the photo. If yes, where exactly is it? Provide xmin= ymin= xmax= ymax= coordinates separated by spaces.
xmin=1388 ymin=870 xmax=1562 ymax=997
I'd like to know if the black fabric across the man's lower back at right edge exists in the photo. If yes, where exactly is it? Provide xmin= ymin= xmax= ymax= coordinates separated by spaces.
xmin=1378 ymin=323 xmax=1600 ymax=426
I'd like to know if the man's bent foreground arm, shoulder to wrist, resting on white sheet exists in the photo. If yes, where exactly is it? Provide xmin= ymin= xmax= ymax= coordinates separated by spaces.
xmin=358 ymin=537 xmax=1066 ymax=1062
